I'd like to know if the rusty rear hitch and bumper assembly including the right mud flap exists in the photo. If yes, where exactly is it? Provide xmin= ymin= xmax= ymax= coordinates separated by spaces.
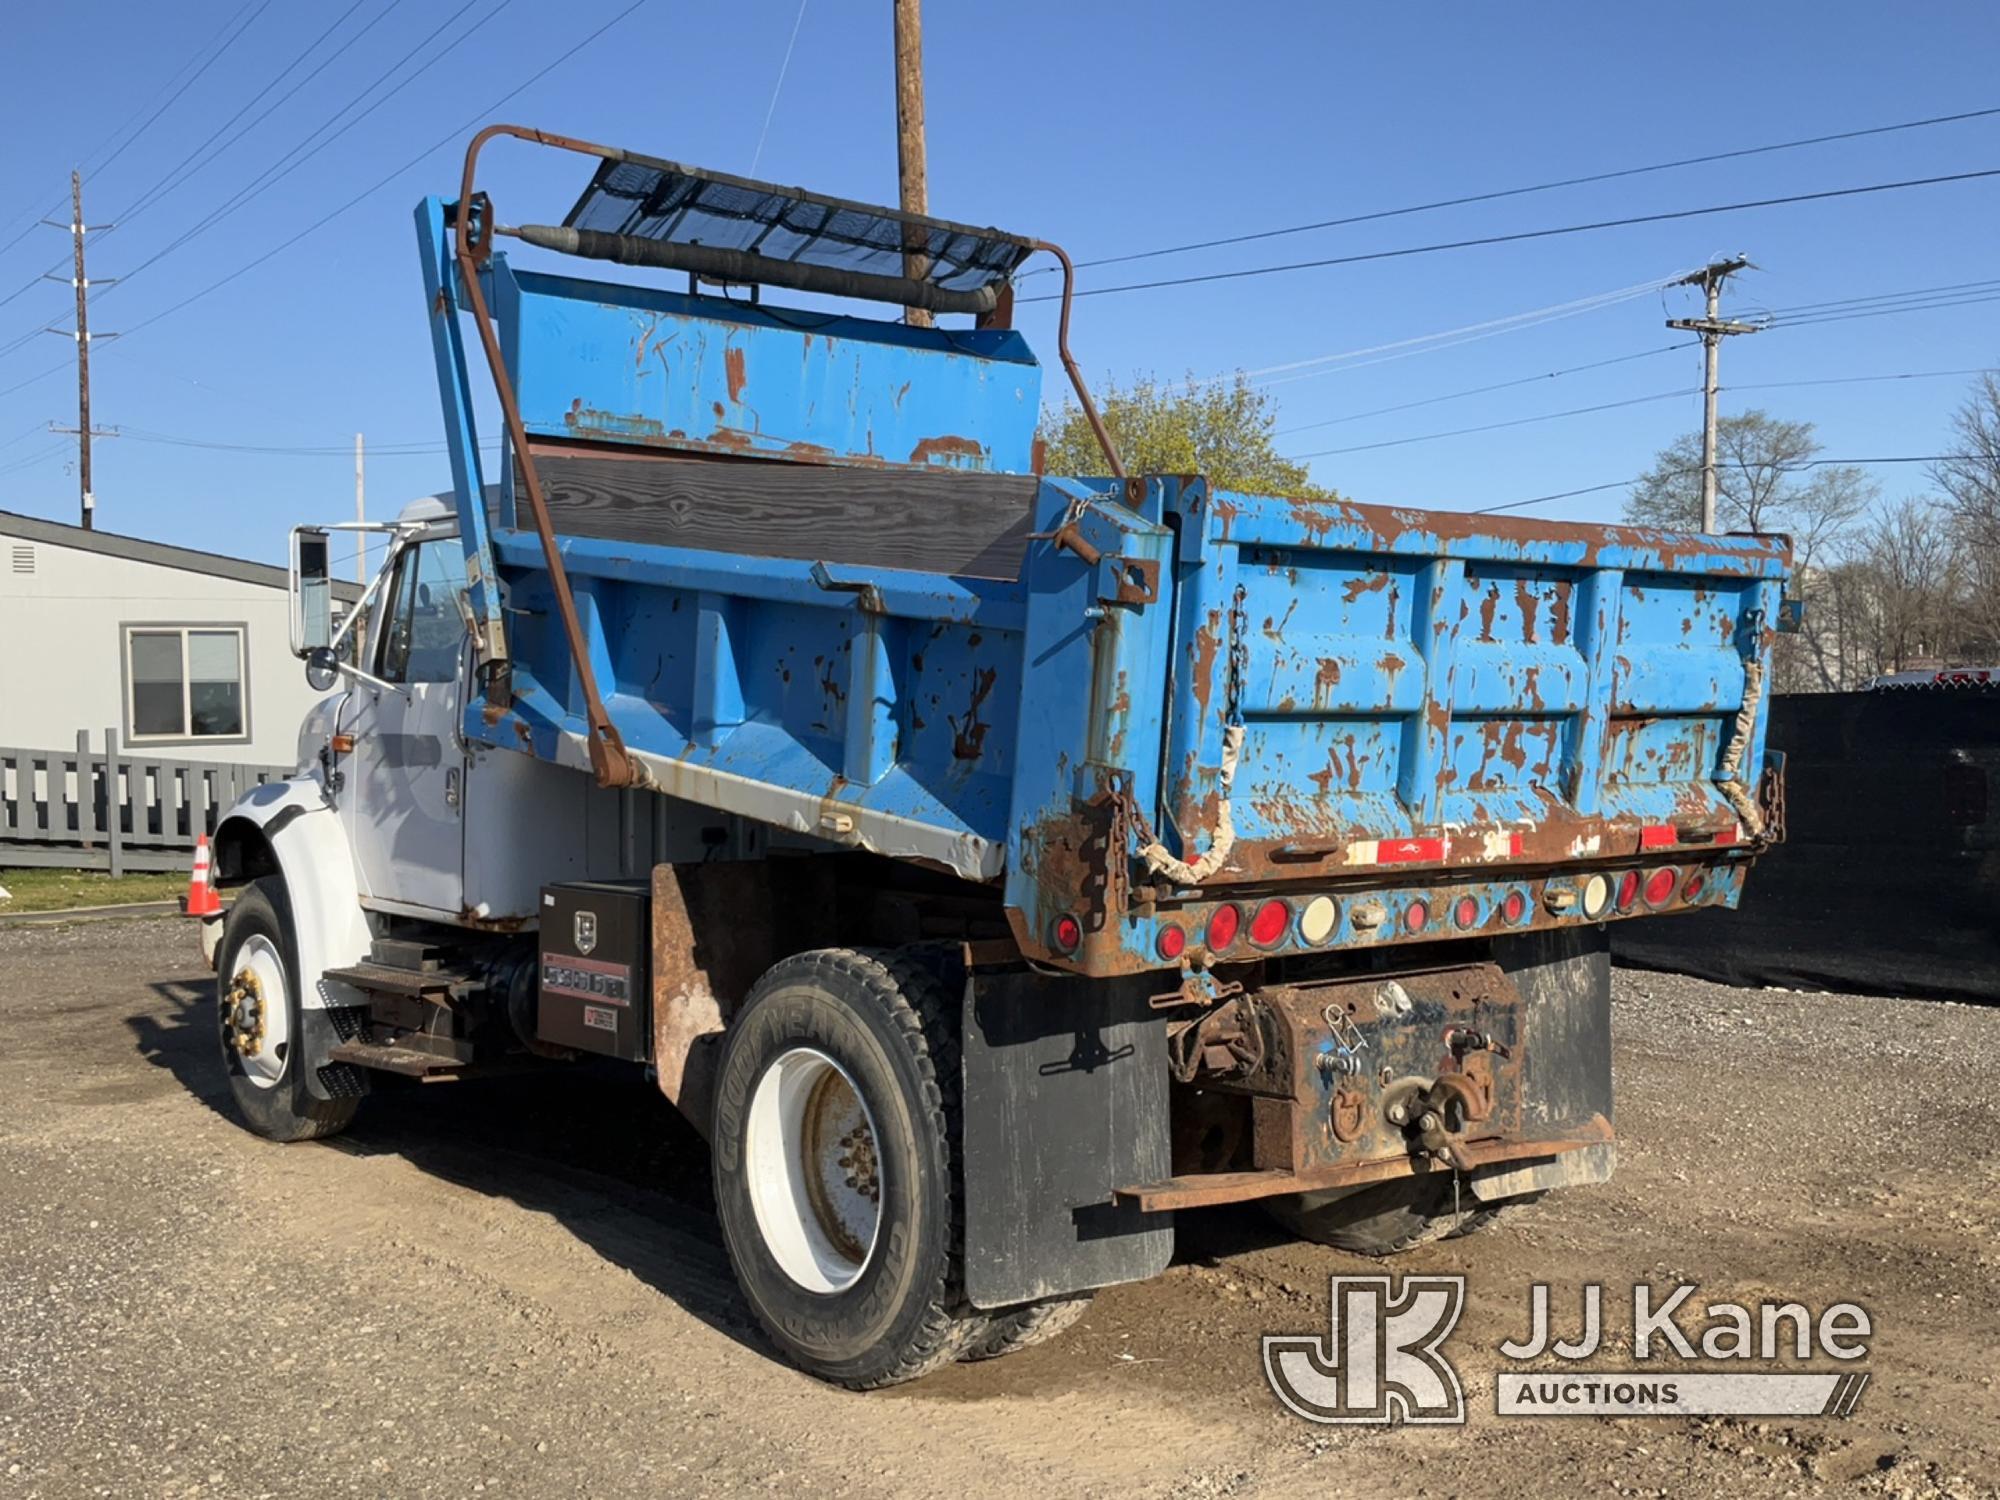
xmin=1116 ymin=926 xmax=1614 ymax=1212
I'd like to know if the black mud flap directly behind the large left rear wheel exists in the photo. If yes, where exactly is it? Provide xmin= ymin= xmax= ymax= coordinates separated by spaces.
xmin=964 ymin=972 xmax=1174 ymax=1308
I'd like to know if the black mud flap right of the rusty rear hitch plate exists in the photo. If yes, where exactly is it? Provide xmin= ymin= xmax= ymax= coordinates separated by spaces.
xmin=1468 ymin=926 xmax=1618 ymax=1202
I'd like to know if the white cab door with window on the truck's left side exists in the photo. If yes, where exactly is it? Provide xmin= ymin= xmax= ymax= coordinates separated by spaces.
xmin=342 ymin=536 xmax=466 ymax=914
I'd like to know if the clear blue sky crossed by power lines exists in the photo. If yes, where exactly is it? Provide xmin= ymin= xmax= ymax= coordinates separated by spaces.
xmin=0 ymin=0 xmax=2000 ymax=560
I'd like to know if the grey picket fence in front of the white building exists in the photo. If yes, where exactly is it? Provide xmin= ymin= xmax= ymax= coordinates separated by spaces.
xmin=0 ymin=730 xmax=292 ymax=874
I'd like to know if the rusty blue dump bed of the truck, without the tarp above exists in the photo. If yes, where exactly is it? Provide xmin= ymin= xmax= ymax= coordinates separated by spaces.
xmin=418 ymin=144 xmax=1790 ymax=988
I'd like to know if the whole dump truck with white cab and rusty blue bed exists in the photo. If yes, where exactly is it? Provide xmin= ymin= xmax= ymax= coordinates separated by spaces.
xmin=202 ymin=126 xmax=1790 ymax=1388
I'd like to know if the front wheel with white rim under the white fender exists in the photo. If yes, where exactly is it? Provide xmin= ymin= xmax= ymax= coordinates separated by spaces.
xmin=216 ymin=876 xmax=358 ymax=1140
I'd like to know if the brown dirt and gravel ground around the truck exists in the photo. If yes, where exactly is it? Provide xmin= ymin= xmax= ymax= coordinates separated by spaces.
xmin=0 ymin=920 xmax=2000 ymax=1500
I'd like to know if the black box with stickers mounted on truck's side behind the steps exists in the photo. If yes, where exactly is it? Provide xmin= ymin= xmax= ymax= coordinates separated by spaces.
xmin=534 ymin=880 xmax=652 ymax=1062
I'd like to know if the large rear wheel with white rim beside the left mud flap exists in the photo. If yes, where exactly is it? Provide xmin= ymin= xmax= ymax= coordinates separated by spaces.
xmin=714 ymin=948 xmax=986 ymax=1390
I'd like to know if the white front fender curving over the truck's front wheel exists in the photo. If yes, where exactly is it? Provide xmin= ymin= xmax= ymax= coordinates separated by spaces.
xmin=216 ymin=776 xmax=374 ymax=1098
